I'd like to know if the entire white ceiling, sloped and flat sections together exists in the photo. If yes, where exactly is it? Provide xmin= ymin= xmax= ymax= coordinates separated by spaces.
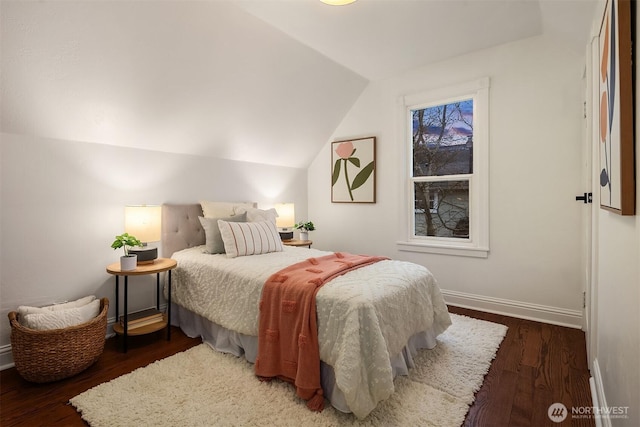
xmin=0 ymin=0 xmax=595 ymax=167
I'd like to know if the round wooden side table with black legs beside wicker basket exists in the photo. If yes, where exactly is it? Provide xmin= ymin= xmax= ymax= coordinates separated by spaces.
xmin=107 ymin=258 xmax=178 ymax=353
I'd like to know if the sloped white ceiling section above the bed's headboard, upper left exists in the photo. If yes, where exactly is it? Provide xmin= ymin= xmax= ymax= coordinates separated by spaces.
xmin=0 ymin=0 xmax=367 ymax=168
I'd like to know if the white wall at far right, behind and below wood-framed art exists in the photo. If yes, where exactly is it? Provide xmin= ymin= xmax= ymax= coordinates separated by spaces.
xmin=589 ymin=2 xmax=640 ymax=426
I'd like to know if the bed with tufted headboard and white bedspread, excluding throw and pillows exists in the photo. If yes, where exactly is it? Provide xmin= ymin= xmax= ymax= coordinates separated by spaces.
xmin=162 ymin=204 xmax=451 ymax=419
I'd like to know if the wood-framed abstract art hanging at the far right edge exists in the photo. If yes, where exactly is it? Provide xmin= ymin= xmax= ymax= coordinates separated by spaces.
xmin=597 ymin=0 xmax=636 ymax=215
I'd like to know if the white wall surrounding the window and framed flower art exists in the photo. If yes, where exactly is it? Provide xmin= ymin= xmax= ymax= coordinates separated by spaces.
xmin=309 ymin=36 xmax=585 ymax=326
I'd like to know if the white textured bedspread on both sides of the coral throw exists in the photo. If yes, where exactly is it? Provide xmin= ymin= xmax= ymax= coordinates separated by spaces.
xmin=172 ymin=246 xmax=451 ymax=418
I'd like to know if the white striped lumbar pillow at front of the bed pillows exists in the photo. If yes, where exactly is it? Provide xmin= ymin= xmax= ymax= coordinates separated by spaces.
xmin=218 ymin=220 xmax=282 ymax=258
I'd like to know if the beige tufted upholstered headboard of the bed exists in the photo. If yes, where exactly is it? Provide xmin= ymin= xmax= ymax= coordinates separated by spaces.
xmin=162 ymin=203 xmax=205 ymax=258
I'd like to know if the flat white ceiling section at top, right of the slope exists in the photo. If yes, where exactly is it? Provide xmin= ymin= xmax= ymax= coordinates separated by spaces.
xmin=238 ymin=0 xmax=596 ymax=80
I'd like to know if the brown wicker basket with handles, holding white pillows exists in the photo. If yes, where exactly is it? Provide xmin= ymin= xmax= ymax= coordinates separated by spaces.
xmin=9 ymin=298 xmax=109 ymax=383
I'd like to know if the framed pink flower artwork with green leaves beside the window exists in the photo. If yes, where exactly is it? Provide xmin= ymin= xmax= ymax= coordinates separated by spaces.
xmin=331 ymin=136 xmax=376 ymax=203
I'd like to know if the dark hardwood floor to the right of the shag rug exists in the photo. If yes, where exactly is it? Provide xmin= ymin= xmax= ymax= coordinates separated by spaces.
xmin=449 ymin=307 xmax=595 ymax=427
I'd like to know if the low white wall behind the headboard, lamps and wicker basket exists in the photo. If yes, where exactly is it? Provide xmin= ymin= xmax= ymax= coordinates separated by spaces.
xmin=0 ymin=133 xmax=307 ymax=366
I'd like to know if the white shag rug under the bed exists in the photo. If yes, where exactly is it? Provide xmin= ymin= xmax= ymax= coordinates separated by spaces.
xmin=70 ymin=314 xmax=507 ymax=427
